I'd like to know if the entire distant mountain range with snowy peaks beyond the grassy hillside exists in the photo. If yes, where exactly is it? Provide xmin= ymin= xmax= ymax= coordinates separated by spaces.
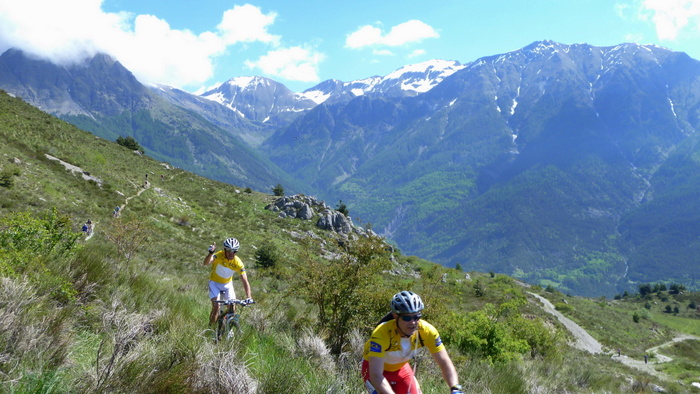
xmin=0 ymin=41 xmax=700 ymax=296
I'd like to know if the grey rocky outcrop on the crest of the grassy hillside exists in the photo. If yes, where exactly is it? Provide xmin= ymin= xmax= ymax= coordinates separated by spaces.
xmin=265 ymin=194 xmax=366 ymax=235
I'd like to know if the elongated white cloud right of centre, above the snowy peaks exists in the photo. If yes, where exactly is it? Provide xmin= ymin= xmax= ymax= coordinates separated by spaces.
xmin=345 ymin=19 xmax=440 ymax=49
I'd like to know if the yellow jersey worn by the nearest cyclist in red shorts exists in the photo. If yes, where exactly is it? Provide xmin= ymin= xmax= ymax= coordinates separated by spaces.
xmin=364 ymin=319 xmax=445 ymax=372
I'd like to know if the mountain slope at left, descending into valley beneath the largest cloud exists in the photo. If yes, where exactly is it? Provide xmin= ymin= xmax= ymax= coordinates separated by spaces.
xmin=0 ymin=50 xmax=303 ymax=190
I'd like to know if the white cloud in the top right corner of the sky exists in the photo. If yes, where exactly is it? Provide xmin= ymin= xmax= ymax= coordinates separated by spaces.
xmin=640 ymin=0 xmax=700 ymax=40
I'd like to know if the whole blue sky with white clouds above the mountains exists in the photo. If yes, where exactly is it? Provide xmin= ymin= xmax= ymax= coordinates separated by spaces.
xmin=0 ymin=0 xmax=700 ymax=92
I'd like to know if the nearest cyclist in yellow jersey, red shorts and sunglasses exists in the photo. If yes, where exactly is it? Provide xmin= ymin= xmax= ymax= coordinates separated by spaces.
xmin=362 ymin=291 xmax=463 ymax=394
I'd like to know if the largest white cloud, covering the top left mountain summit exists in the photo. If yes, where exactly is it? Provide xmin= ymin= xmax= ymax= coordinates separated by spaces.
xmin=0 ymin=0 xmax=280 ymax=87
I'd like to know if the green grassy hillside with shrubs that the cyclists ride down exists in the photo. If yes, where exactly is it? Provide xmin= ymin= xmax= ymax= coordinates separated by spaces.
xmin=0 ymin=93 xmax=700 ymax=393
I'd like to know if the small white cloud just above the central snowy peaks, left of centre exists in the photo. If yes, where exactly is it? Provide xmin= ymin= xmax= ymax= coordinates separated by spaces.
xmin=246 ymin=46 xmax=325 ymax=82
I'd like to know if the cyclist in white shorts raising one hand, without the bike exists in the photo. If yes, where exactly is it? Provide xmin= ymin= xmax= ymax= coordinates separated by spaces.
xmin=202 ymin=238 xmax=254 ymax=325
